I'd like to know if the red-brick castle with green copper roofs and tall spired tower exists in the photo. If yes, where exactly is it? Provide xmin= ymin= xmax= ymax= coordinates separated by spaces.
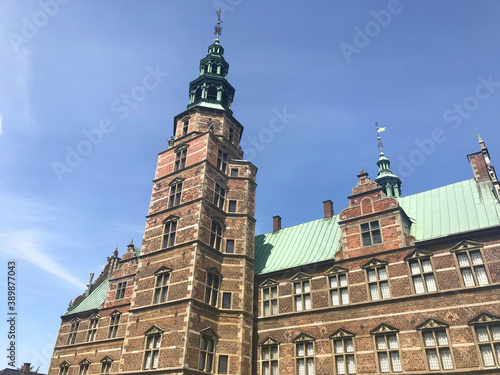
xmin=48 ymin=27 xmax=500 ymax=375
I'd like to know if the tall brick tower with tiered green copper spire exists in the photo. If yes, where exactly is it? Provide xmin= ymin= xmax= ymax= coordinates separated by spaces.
xmin=120 ymin=19 xmax=257 ymax=374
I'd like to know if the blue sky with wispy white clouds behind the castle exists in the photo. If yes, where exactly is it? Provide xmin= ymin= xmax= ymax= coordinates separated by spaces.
xmin=0 ymin=0 xmax=500 ymax=371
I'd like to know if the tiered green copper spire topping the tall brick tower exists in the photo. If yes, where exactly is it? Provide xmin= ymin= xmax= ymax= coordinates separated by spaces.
xmin=187 ymin=11 xmax=235 ymax=114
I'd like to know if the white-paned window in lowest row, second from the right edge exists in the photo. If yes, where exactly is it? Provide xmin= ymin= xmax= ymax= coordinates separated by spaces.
xmin=422 ymin=328 xmax=453 ymax=370
